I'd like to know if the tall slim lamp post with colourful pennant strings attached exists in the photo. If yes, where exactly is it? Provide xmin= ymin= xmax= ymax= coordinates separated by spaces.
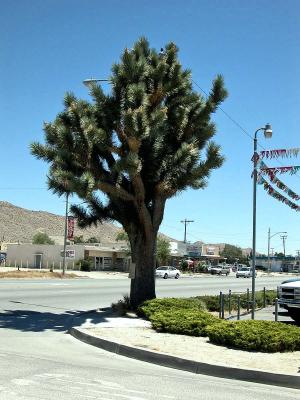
xmin=251 ymin=124 xmax=272 ymax=319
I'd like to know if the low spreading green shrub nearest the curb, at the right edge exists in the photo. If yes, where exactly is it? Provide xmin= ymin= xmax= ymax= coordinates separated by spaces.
xmin=205 ymin=320 xmax=300 ymax=353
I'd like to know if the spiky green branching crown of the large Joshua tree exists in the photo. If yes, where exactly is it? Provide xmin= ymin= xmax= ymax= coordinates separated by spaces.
xmin=32 ymin=38 xmax=226 ymax=306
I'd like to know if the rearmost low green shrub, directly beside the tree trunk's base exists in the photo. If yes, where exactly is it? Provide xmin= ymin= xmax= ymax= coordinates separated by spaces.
xmin=138 ymin=297 xmax=206 ymax=319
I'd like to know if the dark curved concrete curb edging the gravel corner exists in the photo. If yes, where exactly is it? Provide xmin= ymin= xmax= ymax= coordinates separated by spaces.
xmin=68 ymin=327 xmax=300 ymax=389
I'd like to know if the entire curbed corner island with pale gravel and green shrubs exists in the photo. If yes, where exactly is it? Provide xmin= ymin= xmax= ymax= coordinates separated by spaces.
xmin=69 ymin=293 xmax=300 ymax=389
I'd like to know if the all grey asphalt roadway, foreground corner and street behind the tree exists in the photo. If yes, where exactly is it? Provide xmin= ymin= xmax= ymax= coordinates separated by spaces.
xmin=0 ymin=277 xmax=299 ymax=400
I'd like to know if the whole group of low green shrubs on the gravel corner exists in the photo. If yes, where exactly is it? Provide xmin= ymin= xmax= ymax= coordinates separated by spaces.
xmin=138 ymin=295 xmax=300 ymax=353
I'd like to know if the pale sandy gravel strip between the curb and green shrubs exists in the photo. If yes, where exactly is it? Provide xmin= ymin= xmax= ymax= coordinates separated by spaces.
xmin=84 ymin=324 xmax=300 ymax=376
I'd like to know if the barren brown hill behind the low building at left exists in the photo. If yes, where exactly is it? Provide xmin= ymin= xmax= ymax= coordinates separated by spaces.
xmin=0 ymin=201 xmax=120 ymax=243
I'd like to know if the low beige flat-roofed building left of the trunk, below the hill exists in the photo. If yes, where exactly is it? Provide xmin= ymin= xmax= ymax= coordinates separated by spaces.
xmin=6 ymin=244 xmax=129 ymax=271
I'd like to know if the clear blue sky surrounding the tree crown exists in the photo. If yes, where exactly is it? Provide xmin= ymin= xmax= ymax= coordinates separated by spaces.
xmin=0 ymin=0 xmax=300 ymax=253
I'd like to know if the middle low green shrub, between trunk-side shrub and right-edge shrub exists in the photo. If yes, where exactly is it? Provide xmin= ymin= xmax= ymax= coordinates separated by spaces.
xmin=150 ymin=309 xmax=221 ymax=336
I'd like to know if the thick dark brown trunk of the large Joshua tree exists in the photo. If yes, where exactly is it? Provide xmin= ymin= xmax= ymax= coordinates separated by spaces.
xmin=130 ymin=232 xmax=157 ymax=309
